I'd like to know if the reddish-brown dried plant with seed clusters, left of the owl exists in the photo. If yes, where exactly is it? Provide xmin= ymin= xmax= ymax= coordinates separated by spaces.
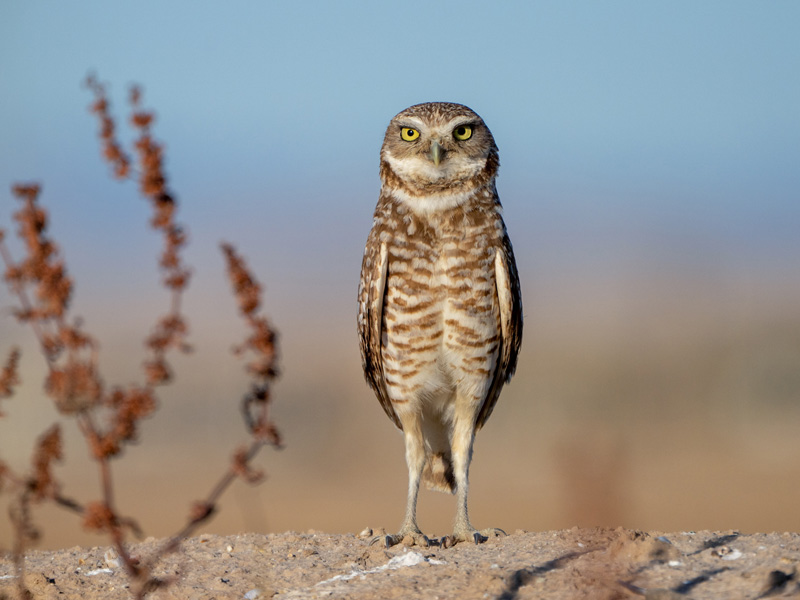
xmin=0 ymin=76 xmax=281 ymax=598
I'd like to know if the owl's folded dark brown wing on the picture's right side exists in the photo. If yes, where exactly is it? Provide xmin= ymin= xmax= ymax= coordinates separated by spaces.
xmin=476 ymin=231 xmax=522 ymax=428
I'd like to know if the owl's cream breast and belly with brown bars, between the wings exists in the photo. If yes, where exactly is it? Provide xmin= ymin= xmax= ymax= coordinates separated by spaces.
xmin=381 ymin=204 xmax=500 ymax=409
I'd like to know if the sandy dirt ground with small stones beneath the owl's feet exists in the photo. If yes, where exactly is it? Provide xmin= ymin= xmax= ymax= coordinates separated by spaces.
xmin=0 ymin=528 xmax=800 ymax=600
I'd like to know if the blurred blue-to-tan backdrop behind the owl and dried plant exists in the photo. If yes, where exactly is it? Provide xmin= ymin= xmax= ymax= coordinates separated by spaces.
xmin=0 ymin=0 xmax=800 ymax=548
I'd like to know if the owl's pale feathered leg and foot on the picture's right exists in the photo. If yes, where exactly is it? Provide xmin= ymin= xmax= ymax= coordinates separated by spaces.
xmin=442 ymin=409 xmax=506 ymax=548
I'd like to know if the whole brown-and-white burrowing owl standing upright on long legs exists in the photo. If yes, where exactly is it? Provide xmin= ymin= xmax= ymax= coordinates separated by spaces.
xmin=358 ymin=102 xmax=522 ymax=546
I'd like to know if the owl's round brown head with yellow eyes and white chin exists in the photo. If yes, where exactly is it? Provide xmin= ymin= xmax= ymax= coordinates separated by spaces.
xmin=381 ymin=102 xmax=499 ymax=211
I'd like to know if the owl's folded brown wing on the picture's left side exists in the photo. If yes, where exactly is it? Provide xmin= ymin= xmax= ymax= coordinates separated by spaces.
xmin=358 ymin=237 xmax=403 ymax=429
